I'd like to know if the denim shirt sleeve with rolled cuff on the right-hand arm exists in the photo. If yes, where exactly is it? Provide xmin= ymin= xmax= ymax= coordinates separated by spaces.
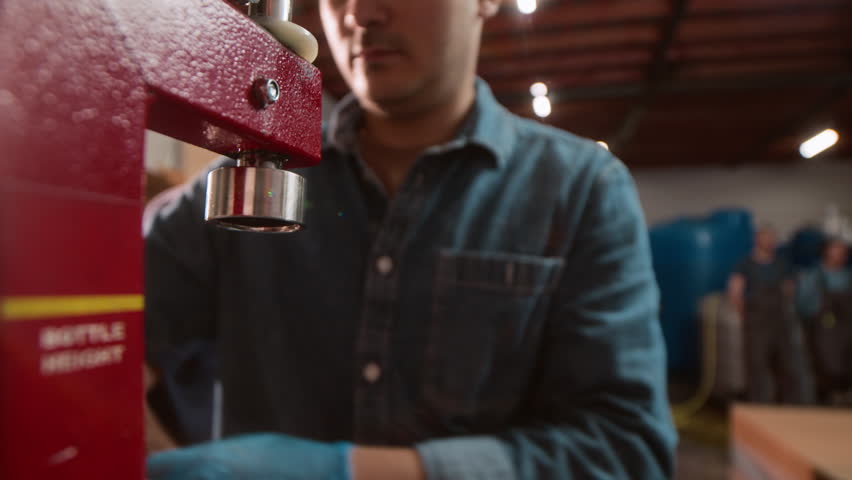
xmin=418 ymin=160 xmax=676 ymax=480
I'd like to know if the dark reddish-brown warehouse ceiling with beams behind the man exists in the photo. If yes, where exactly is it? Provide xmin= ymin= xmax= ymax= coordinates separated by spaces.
xmin=294 ymin=0 xmax=852 ymax=167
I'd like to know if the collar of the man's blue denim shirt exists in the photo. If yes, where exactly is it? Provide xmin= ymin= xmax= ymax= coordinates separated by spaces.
xmin=327 ymin=77 xmax=515 ymax=168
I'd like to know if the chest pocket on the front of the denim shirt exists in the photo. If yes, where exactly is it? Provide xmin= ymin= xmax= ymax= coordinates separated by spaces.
xmin=424 ymin=250 xmax=563 ymax=424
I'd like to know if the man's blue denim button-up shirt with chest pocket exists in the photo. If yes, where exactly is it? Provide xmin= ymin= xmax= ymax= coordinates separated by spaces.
xmin=146 ymin=80 xmax=675 ymax=480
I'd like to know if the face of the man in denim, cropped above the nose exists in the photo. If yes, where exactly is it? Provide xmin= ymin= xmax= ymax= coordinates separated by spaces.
xmin=320 ymin=0 xmax=481 ymax=108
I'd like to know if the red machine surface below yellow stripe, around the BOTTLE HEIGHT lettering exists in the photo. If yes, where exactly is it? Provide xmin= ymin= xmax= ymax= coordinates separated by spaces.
xmin=0 ymin=312 xmax=144 ymax=480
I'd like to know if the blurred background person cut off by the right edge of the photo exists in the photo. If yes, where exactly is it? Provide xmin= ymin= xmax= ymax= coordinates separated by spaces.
xmin=796 ymin=238 xmax=852 ymax=403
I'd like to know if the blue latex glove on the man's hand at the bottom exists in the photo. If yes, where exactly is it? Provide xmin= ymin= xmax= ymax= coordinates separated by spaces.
xmin=147 ymin=433 xmax=352 ymax=480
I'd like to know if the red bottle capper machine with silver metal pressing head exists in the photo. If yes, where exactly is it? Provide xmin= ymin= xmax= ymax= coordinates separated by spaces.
xmin=0 ymin=0 xmax=322 ymax=480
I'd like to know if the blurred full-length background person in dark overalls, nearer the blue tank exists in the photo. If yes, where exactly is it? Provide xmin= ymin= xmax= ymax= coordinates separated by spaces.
xmin=728 ymin=225 xmax=811 ymax=403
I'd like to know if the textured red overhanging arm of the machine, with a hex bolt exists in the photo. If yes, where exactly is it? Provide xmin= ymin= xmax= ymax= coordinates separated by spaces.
xmin=109 ymin=0 xmax=322 ymax=168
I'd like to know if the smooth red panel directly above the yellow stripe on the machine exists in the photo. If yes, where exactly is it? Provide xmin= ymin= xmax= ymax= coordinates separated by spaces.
xmin=0 ymin=190 xmax=143 ymax=296
